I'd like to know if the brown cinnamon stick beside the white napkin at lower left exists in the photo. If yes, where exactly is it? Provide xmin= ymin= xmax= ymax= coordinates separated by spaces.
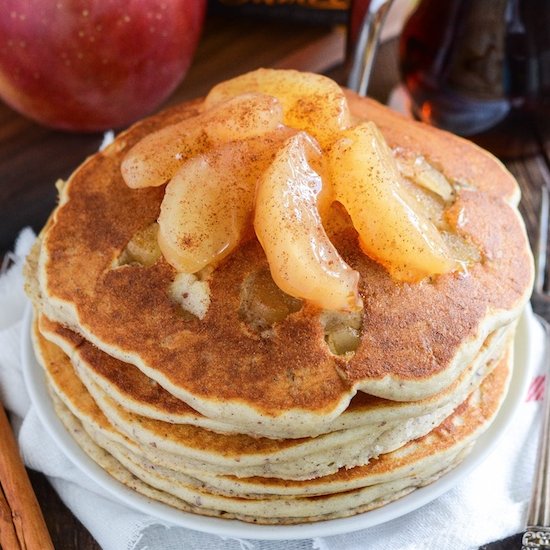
xmin=0 ymin=406 xmax=53 ymax=550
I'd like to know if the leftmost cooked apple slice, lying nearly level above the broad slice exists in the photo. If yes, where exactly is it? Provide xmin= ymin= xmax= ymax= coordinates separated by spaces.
xmin=121 ymin=93 xmax=282 ymax=189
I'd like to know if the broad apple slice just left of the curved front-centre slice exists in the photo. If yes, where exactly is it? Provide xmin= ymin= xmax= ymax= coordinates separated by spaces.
xmin=158 ymin=127 xmax=292 ymax=273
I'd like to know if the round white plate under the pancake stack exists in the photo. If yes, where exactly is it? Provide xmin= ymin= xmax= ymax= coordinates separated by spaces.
xmin=21 ymin=307 xmax=536 ymax=540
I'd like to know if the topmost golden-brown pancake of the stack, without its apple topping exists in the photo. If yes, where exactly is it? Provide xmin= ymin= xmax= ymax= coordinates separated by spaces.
xmin=30 ymin=77 xmax=533 ymax=438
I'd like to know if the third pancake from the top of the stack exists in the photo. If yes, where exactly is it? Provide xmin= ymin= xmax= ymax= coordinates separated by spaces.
xmin=35 ymin=320 xmax=464 ymax=479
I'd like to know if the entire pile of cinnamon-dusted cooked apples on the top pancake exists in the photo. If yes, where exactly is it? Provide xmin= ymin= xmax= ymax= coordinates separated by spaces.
xmin=121 ymin=69 xmax=479 ymax=316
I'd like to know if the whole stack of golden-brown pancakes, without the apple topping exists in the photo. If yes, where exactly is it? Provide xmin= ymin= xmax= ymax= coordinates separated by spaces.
xmin=26 ymin=78 xmax=533 ymax=524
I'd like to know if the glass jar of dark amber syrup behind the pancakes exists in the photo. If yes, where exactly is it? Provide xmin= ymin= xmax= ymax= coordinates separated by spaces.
xmin=400 ymin=0 xmax=550 ymax=158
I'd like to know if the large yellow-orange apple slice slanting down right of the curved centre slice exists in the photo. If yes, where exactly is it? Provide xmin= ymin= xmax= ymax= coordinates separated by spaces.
xmin=328 ymin=122 xmax=462 ymax=282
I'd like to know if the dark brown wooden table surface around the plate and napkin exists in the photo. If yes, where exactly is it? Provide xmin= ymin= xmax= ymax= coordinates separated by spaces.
xmin=0 ymin=9 xmax=550 ymax=550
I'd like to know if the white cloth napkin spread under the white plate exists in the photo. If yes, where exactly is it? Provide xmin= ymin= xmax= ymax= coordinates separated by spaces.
xmin=0 ymin=229 xmax=543 ymax=550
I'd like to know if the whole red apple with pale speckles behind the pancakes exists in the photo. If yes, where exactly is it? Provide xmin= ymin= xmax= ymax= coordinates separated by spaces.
xmin=0 ymin=0 xmax=206 ymax=131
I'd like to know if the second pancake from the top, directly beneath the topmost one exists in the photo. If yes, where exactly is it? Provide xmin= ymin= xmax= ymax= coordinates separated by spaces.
xmin=39 ymin=315 xmax=515 ymax=437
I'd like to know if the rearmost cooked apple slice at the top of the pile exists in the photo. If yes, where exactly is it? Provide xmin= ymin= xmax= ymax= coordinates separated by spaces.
xmin=205 ymin=69 xmax=350 ymax=150
